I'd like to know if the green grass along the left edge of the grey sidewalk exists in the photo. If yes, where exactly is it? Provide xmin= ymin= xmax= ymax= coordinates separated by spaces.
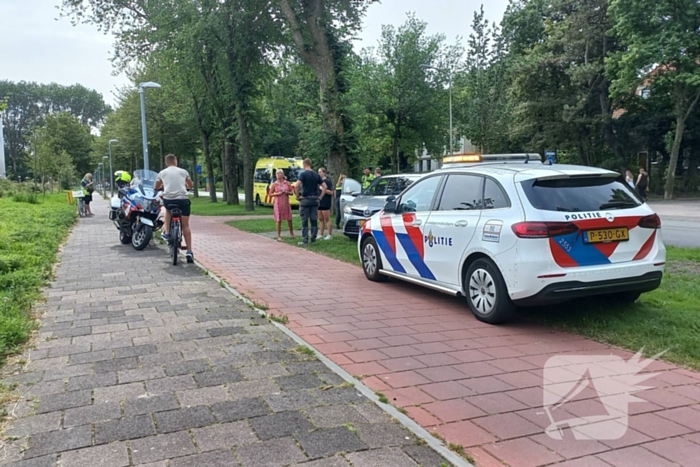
xmin=0 ymin=193 xmax=76 ymax=362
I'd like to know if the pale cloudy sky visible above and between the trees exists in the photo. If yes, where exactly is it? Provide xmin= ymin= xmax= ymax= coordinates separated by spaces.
xmin=0 ymin=0 xmax=508 ymax=105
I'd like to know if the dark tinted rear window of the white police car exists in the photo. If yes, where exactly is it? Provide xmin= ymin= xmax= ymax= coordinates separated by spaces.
xmin=522 ymin=176 xmax=642 ymax=212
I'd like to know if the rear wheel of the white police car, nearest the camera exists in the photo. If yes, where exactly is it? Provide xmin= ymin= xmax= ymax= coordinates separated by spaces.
xmin=464 ymin=258 xmax=516 ymax=324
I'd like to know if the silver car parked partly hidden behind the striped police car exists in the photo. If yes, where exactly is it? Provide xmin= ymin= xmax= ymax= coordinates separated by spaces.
xmin=341 ymin=174 xmax=421 ymax=239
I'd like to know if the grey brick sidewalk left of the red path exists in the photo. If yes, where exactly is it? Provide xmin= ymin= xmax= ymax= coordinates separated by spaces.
xmin=0 ymin=199 xmax=448 ymax=467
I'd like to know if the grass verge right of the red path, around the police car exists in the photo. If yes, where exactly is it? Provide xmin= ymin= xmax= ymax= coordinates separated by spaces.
xmin=229 ymin=214 xmax=700 ymax=370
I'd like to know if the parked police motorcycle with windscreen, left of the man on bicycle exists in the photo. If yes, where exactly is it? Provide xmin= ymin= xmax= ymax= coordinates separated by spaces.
xmin=109 ymin=170 xmax=163 ymax=250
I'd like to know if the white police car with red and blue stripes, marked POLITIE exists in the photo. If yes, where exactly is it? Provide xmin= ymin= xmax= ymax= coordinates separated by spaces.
xmin=358 ymin=154 xmax=666 ymax=324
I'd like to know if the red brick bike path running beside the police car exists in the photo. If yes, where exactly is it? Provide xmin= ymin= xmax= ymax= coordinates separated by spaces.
xmin=192 ymin=217 xmax=700 ymax=467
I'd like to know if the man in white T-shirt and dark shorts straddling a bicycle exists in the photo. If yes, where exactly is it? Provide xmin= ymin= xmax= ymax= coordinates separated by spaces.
xmin=155 ymin=154 xmax=194 ymax=263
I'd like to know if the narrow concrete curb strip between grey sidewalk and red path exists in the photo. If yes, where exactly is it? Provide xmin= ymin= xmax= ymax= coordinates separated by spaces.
xmin=194 ymin=259 xmax=475 ymax=467
